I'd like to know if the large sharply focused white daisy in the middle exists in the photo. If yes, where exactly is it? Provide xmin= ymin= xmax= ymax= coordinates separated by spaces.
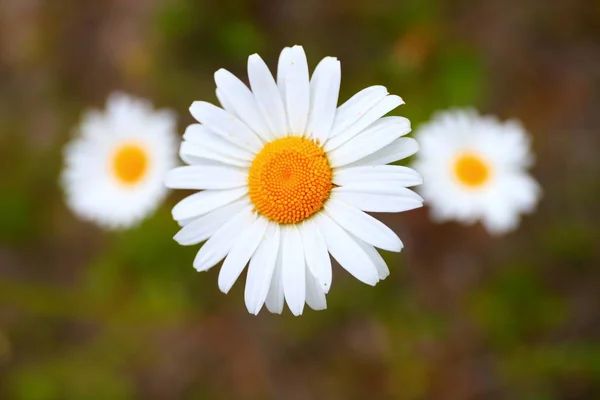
xmin=166 ymin=46 xmax=422 ymax=315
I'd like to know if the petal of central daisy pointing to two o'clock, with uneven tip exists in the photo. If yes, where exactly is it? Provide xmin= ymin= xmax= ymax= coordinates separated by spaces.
xmin=328 ymin=117 xmax=410 ymax=168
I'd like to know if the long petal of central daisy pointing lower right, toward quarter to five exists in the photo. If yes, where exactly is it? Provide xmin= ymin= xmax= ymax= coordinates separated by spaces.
xmin=314 ymin=213 xmax=379 ymax=286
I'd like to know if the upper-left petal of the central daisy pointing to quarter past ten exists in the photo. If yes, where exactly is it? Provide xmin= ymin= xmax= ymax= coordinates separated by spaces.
xmin=190 ymin=101 xmax=263 ymax=153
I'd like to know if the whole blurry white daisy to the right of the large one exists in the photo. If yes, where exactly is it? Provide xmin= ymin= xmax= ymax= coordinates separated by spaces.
xmin=413 ymin=110 xmax=540 ymax=234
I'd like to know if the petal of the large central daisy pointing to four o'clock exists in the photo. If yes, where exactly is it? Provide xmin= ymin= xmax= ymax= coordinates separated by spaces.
xmin=325 ymin=199 xmax=402 ymax=252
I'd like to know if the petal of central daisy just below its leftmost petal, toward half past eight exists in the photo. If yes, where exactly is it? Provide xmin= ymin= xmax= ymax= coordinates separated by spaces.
xmin=171 ymin=188 xmax=248 ymax=221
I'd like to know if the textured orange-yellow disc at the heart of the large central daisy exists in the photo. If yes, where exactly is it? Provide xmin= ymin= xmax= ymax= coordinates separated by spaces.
xmin=248 ymin=137 xmax=332 ymax=224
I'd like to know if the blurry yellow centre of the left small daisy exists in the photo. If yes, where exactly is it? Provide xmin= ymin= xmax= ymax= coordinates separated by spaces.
xmin=112 ymin=143 xmax=149 ymax=185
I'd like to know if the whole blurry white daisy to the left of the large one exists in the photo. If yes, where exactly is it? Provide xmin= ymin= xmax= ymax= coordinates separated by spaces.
xmin=61 ymin=94 xmax=177 ymax=229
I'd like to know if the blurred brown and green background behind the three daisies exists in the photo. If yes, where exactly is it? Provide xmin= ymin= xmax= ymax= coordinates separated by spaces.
xmin=0 ymin=0 xmax=600 ymax=400
